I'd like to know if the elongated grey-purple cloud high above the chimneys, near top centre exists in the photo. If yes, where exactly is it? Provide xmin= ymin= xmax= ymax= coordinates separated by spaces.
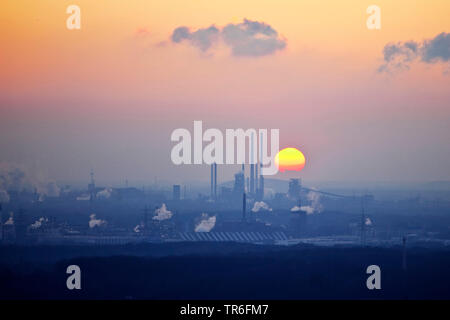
xmin=171 ymin=19 xmax=286 ymax=57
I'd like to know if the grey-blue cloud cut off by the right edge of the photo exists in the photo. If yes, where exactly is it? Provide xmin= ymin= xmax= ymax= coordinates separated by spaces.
xmin=378 ymin=32 xmax=450 ymax=73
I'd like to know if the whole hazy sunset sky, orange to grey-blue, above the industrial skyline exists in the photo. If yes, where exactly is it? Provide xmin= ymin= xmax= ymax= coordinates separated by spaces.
xmin=0 ymin=0 xmax=450 ymax=183
